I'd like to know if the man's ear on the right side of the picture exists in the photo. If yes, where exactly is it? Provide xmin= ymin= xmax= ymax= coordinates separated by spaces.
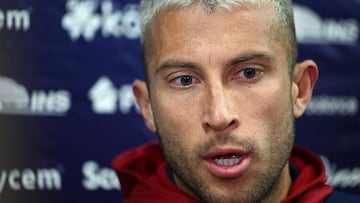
xmin=292 ymin=60 xmax=319 ymax=118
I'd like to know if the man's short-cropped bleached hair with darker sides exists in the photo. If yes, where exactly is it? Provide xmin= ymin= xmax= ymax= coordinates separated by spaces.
xmin=140 ymin=0 xmax=297 ymax=71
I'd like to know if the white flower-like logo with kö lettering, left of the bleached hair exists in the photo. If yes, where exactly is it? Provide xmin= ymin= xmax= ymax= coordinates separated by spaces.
xmin=61 ymin=0 xmax=140 ymax=41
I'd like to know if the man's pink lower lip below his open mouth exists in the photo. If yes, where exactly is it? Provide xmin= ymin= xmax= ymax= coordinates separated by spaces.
xmin=205 ymin=156 xmax=250 ymax=178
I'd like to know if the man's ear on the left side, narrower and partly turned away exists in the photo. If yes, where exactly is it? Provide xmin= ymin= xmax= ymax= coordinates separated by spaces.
xmin=132 ymin=80 xmax=156 ymax=132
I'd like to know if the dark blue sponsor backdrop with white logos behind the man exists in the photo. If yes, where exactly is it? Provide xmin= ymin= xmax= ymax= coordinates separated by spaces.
xmin=0 ymin=0 xmax=360 ymax=203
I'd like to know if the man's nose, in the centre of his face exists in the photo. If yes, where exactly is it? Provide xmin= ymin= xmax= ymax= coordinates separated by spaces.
xmin=203 ymin=85 xmax=239 ymax=135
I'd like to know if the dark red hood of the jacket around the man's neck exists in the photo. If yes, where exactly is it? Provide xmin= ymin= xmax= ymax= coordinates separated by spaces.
xmin=113 ymin=143 xmax=332 ymax=203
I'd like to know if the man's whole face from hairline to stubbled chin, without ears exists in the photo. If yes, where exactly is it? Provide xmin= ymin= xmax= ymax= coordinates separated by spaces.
xmin=146 ymin=1 xmax=293 ymax=202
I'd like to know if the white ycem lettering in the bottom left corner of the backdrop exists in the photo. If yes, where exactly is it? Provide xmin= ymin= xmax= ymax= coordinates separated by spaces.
xmin=0 ymin=168 xmax=62 ymax=195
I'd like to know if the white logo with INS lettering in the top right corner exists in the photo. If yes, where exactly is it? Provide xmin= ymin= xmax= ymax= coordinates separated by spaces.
xmin=293 ymin=4 xmax=360 ymax=45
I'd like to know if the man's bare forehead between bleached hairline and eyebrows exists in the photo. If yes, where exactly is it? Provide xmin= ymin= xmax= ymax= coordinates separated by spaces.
xmin=146 ymin=3 xmax=282 ymax=70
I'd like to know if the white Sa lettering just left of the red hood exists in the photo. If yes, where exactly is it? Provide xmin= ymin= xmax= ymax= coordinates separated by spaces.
xmin=82 ymin=161 xmax=121 ymax=191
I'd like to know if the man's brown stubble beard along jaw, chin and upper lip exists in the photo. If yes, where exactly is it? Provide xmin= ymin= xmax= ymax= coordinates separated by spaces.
xmin=155 ymin=106 xmax=294 ymax=203
